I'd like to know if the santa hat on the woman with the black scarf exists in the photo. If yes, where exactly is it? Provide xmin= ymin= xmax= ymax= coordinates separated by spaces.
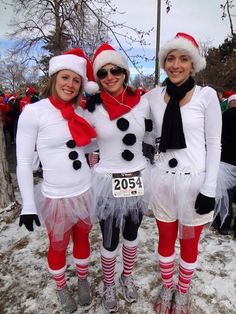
xmin=159 ymin=33 xmax=206 ymax=74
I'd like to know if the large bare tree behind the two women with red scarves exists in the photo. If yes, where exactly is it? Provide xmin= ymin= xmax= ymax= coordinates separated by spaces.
xmin=5 ymin=0 xmax=151 ymax=72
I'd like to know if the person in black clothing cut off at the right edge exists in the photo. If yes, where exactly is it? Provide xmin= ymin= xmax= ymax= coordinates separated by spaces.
xmin=213 ymin=94 xmax=236 ymax=237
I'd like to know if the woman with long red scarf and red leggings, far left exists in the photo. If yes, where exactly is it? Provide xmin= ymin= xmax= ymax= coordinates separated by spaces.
xmin=16 ymin=48 xmax=96 ymax=313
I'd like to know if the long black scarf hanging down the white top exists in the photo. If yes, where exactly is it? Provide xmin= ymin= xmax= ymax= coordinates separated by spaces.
xmin=159 ymin=76 xmax=195 ymax=152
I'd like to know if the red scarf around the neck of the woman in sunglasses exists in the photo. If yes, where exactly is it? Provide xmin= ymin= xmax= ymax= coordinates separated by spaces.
xmin=100 ymin=90 xmax=141 ymax=120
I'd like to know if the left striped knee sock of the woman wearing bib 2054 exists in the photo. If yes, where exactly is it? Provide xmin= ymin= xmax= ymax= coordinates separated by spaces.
xmin=101 ymin=247 xmax=116 ymax=286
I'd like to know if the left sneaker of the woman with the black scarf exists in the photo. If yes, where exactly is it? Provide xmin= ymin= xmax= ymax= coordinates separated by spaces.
xmin=155 ymin=286 xmax=174 ymax=314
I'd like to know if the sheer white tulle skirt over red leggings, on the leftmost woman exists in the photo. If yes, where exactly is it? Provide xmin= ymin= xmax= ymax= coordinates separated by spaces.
xmin=35 ymin=184 xmax=96 ymax=247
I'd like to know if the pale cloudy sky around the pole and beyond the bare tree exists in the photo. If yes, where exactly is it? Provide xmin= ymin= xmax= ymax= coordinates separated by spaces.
xmin=0 ymin=0 xmax=236 ymax=74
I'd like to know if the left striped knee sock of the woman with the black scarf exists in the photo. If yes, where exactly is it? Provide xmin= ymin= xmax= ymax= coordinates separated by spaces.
xmin=158 ymin=254 xmax=175 ymax=288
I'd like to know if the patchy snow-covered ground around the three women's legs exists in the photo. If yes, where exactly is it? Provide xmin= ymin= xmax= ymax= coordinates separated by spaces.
xmin=0 ymin=175 xmax=236 ymax=314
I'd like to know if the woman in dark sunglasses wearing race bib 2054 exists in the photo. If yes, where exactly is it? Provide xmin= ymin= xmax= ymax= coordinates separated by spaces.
xmin=85 ymin=43 xmax=152 ymax=313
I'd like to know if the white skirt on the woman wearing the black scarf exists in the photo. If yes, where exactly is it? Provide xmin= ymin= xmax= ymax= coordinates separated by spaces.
xmin=150 ymin=162 xmax=213 ymax=238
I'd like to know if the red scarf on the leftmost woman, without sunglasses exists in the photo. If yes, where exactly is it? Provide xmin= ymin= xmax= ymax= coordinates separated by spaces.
xmin=49 ymin=96 xmax=97 ymax=146
